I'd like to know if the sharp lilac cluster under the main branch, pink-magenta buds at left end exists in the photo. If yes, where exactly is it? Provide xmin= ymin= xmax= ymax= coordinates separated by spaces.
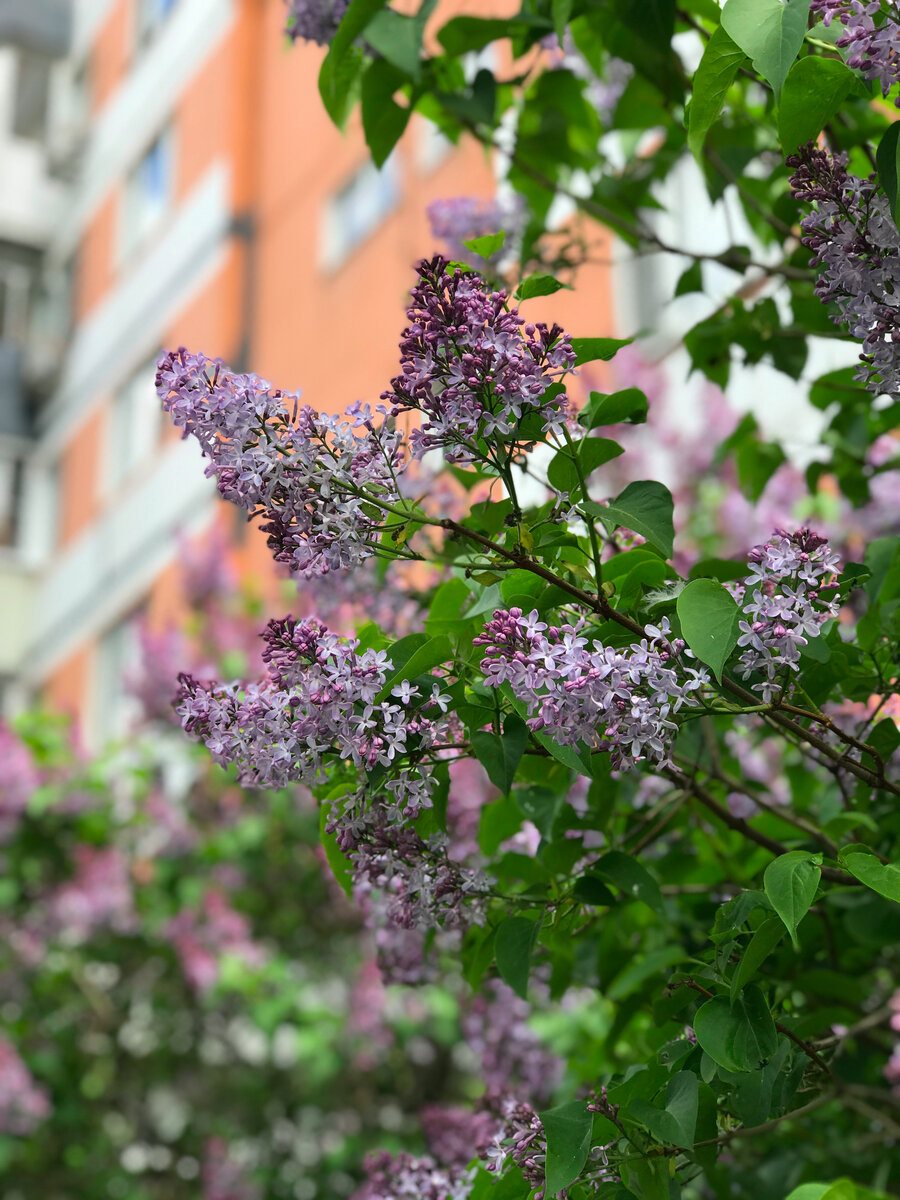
xmin=475 ymin=608 xmax=709 ymax=767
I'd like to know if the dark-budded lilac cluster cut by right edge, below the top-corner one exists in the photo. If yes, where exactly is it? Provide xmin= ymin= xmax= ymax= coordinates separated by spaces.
xmin=786 ymin=143 xmax=900 ymax=392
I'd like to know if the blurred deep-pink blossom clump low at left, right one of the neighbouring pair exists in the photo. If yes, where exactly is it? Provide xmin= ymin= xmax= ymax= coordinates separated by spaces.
xmin=166 ymin=888 xmax=265 ymax=991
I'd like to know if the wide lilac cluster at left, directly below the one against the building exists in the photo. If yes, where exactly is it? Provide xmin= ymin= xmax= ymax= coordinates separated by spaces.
xmin=176 ymin=617 xmax=449 ymax=816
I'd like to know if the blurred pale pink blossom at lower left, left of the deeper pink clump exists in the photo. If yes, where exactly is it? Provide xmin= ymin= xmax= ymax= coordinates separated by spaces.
xmin=48 ymin=846 xmax=137 ymax=942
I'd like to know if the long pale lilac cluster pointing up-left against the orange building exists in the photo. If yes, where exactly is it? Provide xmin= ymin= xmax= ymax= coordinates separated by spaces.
xmin=156 ymin=347 xmax=402 ymax=576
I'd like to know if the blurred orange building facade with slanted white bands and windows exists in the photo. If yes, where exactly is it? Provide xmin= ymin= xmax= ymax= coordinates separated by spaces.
xmin=12 ymin=0 xmax=614 ymax=742
